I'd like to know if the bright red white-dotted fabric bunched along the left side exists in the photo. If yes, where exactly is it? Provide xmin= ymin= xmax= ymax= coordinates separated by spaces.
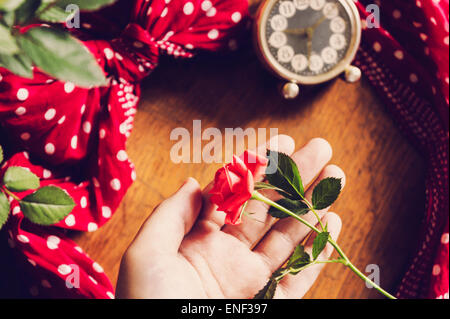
xmin=0 ymin=0 xmax=248 ymax=298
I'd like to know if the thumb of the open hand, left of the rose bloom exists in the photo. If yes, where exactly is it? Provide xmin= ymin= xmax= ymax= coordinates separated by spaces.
xmin=130 ymin=178 xmax=202 ymax=254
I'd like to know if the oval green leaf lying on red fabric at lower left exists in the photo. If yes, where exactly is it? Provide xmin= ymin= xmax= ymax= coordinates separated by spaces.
xmin=20 ymin=186 xmax=75 ymax=226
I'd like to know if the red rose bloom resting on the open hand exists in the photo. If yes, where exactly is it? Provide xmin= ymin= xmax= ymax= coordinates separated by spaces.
xmin=209 ymin=151 xmax=268 ymax=225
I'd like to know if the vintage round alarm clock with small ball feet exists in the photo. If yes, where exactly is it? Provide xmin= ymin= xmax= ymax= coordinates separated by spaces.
xmin=254 ymin=0 xmax=361 ymax=99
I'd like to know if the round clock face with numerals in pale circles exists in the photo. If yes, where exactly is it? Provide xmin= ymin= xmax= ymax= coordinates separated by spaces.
xmin=259 ymin=0 xmax=359 ymax=84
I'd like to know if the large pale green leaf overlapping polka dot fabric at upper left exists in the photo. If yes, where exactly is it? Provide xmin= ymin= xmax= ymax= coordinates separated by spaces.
xmin=18 ymin=27 xmax=106 ymax=88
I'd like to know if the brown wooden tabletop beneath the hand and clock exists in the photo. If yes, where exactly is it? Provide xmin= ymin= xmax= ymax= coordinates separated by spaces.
xmin=68 ymin=48 xmax=424 ymax=298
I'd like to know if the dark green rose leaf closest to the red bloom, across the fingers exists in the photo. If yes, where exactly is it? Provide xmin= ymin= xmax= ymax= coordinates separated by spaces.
xmin=266 ymin=150 xmax=305 ymax=199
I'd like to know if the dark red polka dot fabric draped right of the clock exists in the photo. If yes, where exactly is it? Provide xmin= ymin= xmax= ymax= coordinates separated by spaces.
xmin=355 ymin=0 xmax=449 ymax=299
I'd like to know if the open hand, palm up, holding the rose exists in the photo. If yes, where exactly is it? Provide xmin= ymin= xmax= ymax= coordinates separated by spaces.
xmin=116 ymin=135 xmax=344 ymax=299
